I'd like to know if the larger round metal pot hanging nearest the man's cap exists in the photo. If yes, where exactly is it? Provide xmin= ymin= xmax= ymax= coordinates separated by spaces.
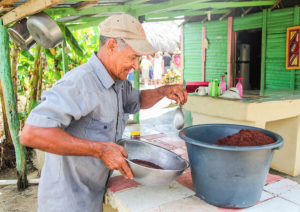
xmin=27 ymin=12 xmax=64 ymax=49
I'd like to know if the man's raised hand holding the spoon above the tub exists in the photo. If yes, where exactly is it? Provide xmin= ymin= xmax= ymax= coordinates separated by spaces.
xmin=158 ymin=85 xmax=187 ymax=104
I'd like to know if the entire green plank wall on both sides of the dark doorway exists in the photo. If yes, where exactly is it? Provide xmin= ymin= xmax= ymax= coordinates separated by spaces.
xmin=184 ymin=7 xmax=300 ymax=89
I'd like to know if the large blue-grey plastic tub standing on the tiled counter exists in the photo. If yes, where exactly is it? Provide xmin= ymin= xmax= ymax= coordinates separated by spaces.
xmin=179 ymin=124 xmax=283 ymax=208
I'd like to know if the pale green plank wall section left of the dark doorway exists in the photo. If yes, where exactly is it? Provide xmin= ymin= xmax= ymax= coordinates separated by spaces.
xmin=184 ymin=20 xmax=228 ymax=82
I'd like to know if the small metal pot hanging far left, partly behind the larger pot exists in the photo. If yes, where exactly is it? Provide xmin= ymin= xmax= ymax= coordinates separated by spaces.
xmin=7 ymin=18 xmax=36 ymax=51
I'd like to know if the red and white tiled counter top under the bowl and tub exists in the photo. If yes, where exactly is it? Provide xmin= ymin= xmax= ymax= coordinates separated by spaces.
xmin=105 ymin=128 xmax=300 ymax=212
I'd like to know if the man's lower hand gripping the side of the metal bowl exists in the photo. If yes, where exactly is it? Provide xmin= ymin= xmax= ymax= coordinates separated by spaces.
xmin=93 ymin=142 xmax=133 ymax=179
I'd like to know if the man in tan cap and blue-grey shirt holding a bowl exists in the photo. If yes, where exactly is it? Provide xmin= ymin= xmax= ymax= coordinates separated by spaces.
xmin=21 ymin=14 xmax=187 ymax=212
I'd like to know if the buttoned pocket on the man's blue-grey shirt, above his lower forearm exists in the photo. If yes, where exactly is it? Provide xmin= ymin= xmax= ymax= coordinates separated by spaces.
xmin=85 ymin=117 xmax=116 ymax=142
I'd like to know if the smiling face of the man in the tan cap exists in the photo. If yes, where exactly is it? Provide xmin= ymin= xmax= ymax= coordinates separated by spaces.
xmin=110 ymin=39 xmax=141 ymax=80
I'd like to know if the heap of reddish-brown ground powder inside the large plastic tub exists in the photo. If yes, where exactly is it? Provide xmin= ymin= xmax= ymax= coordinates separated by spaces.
xmin=215 ymin=129 xmax=275 ymax=146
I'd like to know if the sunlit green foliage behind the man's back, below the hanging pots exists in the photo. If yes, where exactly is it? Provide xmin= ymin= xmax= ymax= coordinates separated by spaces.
xmin=10 ymin=23 xmax=100 ymax=123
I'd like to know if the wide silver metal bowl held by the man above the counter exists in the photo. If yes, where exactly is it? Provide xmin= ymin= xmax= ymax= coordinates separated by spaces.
xmin=118 ymin=139 xmax=190 ymax=186
